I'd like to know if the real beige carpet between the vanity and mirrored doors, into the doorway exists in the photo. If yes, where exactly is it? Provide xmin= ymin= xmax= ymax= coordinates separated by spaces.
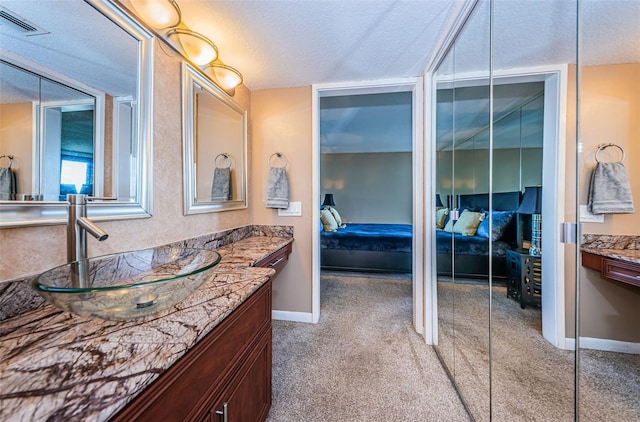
xmin=268 ymin=273 xmax=469 ymax=422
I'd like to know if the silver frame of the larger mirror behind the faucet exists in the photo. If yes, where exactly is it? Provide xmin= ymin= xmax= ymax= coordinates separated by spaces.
xmin=0 ymin=0 xmax=155 ymax=228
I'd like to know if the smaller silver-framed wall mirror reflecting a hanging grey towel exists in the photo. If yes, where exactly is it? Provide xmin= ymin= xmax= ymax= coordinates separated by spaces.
xmin=182 ymin=62 xmax=247 ymax=215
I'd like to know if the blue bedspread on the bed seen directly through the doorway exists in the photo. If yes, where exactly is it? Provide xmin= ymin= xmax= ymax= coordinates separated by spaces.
xmin=320 ymin=223 xmax=413 ymax=252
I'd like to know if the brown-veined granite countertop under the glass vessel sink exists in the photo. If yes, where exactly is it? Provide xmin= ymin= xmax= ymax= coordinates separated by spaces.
xmin=0 ymin=236 xmax=293 ymax=421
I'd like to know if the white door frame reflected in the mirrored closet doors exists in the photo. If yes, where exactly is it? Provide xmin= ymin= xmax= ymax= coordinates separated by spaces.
xmin=424 ymin=64 xmax=570 ymax=349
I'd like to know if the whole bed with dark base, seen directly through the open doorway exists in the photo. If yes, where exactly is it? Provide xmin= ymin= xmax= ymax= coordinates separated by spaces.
xmin=320 ymin=223 xmax=413 ymax=273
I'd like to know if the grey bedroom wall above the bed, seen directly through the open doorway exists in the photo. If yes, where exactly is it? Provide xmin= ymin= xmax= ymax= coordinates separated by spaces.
xmin=320 ymin=152 xmax=413 ymax=224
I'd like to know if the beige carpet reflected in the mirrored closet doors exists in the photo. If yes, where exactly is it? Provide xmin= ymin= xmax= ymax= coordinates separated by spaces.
xmin=438 ymin=281 xmax=640 ymax=421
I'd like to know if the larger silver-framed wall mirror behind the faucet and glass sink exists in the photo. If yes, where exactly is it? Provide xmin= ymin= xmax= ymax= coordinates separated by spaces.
xmin=0 ymin=0 xmax=153 ymax=227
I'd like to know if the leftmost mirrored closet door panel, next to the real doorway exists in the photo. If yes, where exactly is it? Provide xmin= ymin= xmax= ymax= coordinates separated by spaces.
xmin=434 ymin=2 xmax=491 ymax=420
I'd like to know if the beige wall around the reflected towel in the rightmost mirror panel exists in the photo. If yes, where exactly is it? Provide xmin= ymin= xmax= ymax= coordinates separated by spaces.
xmin=565 ymin=63 xmax=640 ymax=343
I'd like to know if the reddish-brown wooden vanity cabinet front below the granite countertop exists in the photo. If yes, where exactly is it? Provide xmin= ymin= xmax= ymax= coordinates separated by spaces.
xmin=113 ymin=280 xmax=271 ymax=422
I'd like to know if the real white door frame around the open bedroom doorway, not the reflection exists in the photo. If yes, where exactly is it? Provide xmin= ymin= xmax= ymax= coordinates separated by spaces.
xmin=311 ymin=77 xmax=426 ymax=334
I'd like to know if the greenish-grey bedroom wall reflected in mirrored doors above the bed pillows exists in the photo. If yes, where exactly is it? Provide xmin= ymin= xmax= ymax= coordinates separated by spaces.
xmin=436 ymin=148 xmax=542 ymax=196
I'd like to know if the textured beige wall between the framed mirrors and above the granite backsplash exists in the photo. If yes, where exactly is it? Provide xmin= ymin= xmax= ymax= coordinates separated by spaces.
xmin=0 ymin=41 xmax=251 ymax=281
